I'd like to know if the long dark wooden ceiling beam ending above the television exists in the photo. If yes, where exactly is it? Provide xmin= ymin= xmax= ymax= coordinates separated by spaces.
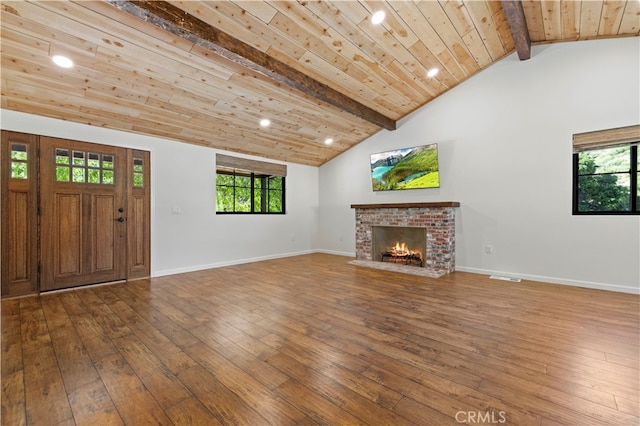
xmin=107 ymin=0 xmax=396 ymax=130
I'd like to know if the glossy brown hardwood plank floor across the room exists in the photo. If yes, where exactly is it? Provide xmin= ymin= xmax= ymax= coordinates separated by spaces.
xmin=2 ymin=254 xmax=640 ymax=426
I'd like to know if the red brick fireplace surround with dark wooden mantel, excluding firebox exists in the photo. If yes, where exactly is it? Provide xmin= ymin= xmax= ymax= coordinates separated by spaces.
xmin=351 ymin=201 xmax=460 ymax=274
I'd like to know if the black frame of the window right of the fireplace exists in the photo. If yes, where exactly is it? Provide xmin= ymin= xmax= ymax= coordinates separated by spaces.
xmin=572 ymin=142 xmax=640 ymax=216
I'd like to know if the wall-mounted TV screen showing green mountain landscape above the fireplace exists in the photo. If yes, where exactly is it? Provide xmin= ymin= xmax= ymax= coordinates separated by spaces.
xmin=371 ymin=143 xmax=440 ymax=191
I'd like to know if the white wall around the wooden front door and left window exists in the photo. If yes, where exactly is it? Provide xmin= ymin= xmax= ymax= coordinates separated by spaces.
xmin=0 ymin=110 xmax=318 ymax=276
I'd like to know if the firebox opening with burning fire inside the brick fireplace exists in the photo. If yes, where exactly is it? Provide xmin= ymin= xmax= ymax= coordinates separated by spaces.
xmin=371 ymin=226 xmax=427 ymax=267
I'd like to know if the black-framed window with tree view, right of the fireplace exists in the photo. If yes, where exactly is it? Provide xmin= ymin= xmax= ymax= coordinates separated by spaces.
xmin=573 ymin=129 xmax=640 ymax=214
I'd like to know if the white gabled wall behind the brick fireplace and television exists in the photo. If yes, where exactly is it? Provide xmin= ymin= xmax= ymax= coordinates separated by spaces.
xmin=319 ymin=37 xmax=640 ymax=293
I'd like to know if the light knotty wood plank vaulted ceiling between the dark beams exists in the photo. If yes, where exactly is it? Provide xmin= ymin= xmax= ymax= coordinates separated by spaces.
xmin=1 ymin=0 xmax=640 ymax=166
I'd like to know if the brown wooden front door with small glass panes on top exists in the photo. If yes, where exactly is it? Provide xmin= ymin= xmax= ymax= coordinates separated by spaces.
xmin=40 ymin=136 xmax=128 ymax=291
